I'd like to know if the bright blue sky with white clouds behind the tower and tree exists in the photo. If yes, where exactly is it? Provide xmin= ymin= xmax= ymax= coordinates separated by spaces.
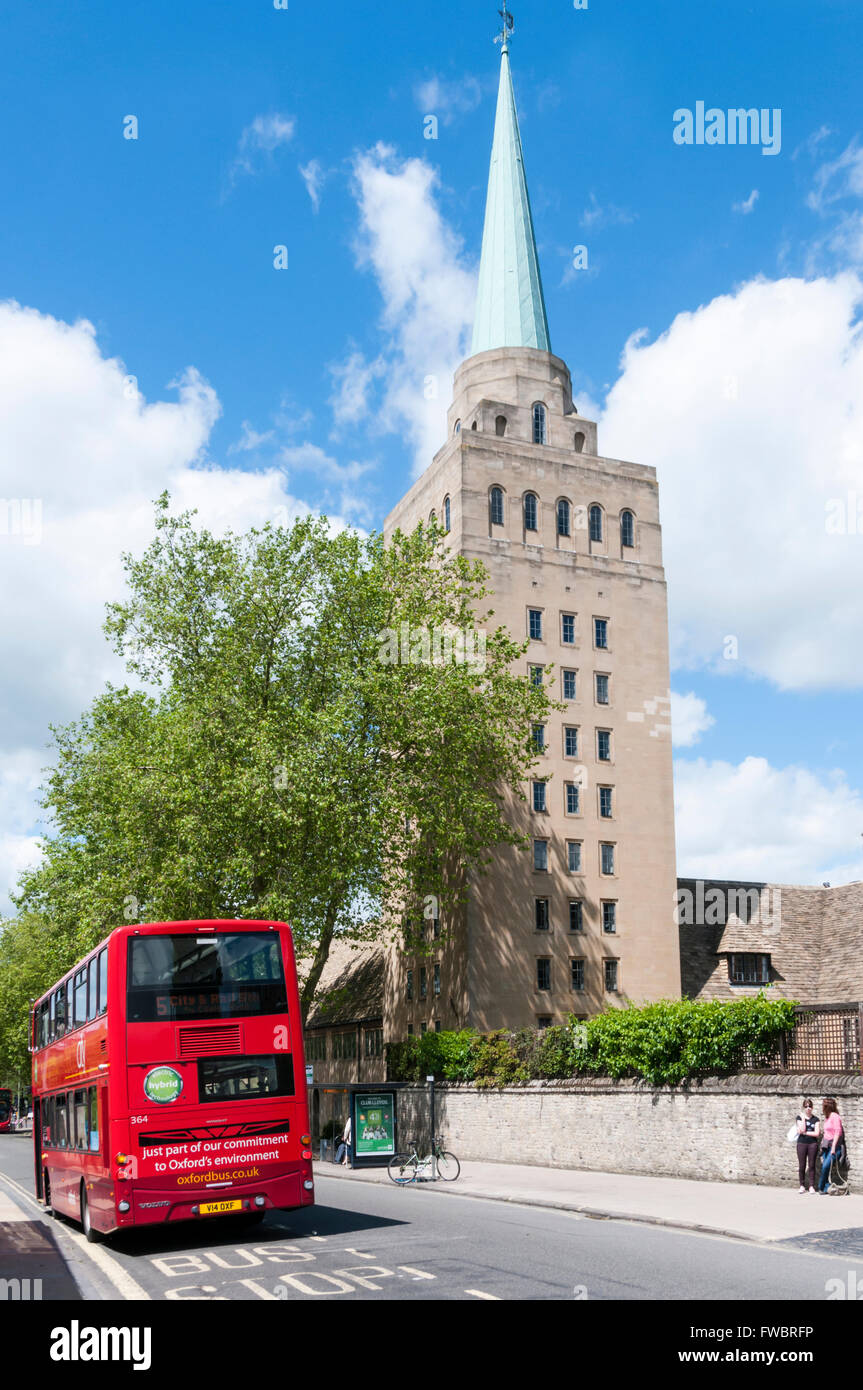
xmin=0 ymin=0 xmax=863 ymax=881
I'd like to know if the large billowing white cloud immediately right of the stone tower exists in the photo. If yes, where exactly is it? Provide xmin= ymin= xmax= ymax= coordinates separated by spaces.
xmin=600 ymin=272 xmax=863 ymax=689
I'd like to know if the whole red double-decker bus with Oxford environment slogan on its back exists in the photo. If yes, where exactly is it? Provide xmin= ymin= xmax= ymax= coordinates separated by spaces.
xmin=32 ymin=922 xmax=314 ymax=1240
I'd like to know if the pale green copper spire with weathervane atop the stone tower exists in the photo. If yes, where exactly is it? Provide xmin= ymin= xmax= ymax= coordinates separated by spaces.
xmin=471 ymin=4 xmax=552 ymax=353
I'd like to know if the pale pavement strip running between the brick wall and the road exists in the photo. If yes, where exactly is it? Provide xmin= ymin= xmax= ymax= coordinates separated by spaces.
xmin=314 ymin=1161 xmax=863 ymax=1243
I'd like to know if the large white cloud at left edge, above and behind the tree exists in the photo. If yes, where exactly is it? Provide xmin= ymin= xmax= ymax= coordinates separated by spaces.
xmin=0 ymin=303 xmax=351 ymax=911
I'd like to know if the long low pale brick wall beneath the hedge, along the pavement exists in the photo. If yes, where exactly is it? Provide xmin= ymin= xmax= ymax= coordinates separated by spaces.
xmin=396 ymin=1074 xmax=863 ymax=1187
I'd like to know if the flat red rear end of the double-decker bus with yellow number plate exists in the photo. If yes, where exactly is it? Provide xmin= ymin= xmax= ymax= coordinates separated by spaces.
xmin=111 ymin=922 xmax=314 ymax=1227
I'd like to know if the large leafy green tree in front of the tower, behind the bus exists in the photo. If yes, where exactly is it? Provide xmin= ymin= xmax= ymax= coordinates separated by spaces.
xmin=17 ymin=496 xmax=550 ymax=1013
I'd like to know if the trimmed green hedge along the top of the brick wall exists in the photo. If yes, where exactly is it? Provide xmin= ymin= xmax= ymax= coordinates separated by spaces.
xmin=386 ymin=994 xmax=795 ymax=1087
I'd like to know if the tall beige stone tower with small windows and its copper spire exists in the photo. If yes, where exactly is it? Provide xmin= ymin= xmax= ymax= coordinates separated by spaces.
xmin=385 ymin=21 xmax=680 ymax=1037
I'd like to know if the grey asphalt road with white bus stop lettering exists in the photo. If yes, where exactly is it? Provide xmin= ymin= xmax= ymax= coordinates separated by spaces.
xmin=0 ymin=1136 xmax=863 ymax=1301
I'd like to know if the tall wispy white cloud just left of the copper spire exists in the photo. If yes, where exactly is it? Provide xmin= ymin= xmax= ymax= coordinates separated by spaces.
xmin=346 ymin=145 xmax=477 ymax=473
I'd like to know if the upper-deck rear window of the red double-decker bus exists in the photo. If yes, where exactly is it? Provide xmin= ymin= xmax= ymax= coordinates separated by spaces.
xmin=126 ymin=931 xmax=288 ymax=1023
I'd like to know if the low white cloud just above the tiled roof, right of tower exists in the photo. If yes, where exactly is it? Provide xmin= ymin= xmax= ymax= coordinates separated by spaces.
xmin=674 ymin=758 xmax=863 ymax=884
